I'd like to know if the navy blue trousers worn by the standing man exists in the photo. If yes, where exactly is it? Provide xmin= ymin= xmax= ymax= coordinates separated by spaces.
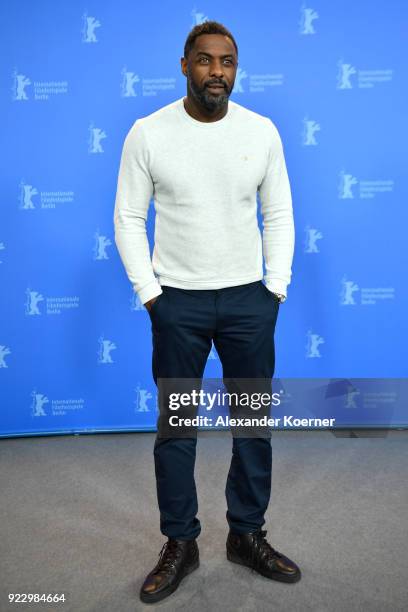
xmin=149 ymin=281 xmax=279 ymax=540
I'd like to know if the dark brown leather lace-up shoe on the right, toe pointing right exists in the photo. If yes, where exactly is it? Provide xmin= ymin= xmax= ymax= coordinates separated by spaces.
xmin=227 ymin=529 xmax=301 ymax=582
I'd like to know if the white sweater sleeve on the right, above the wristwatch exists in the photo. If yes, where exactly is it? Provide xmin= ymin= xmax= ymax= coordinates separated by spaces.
xmin=258 ymin=118 xmax=295 ymax=296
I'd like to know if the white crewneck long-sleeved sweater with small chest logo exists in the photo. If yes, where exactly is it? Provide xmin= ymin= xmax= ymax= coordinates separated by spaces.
xmin=114 ymin=98 xmax=295 ymax=304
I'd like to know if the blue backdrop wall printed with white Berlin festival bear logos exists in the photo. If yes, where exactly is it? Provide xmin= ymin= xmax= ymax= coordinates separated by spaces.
xmin=0 ymin=0 xmax=408 ymax=435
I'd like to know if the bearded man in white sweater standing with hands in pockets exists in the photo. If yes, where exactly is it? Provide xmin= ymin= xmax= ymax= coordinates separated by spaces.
xmin=114 ymin=21 xmax=301 ymax=603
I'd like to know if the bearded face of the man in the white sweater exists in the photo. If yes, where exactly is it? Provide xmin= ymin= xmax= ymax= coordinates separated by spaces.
xmin=181 ymin=34 xmax=238 ymax=111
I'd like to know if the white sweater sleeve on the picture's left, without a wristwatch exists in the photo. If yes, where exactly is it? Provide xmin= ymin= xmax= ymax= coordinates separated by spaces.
xmin=113 ymin=119 xmax=162 ymax=304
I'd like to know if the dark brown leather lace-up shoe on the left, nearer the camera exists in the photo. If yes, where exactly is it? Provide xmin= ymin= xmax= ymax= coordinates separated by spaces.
xmin=140 ymin=538 xmax=200 ymax=603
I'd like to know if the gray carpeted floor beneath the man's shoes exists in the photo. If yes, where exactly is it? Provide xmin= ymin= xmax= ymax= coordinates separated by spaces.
xmin=0 ymin=431 xmax=408 ymax=612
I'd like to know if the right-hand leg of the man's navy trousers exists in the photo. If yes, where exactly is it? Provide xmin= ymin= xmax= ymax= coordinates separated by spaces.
xmin=214 ymin=282 xmax=279 ymax=533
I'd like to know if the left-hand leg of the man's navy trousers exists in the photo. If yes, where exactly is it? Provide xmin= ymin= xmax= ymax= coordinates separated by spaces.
xmin=150 ymin=286 xmax=212 ymax=540
